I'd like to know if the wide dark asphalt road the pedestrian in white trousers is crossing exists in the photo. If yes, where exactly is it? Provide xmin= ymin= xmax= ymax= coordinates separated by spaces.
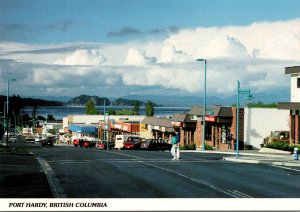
xmin=30 ymin=146 xmax=300 ymax=198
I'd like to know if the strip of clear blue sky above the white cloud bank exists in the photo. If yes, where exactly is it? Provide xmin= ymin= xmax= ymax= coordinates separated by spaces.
xmin=0 ymin=0 xmax=300 ymax=43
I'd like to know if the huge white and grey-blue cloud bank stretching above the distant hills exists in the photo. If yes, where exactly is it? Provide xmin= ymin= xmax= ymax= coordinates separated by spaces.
xmin=0 ymin=19 xmax=300 ymax=100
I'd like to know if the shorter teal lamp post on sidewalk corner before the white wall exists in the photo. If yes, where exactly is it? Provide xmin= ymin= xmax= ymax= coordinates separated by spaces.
xmin=236 ymin=81 xmax=253 ymax=158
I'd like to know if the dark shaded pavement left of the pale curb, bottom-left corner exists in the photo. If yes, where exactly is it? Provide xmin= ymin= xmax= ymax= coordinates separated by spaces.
xmin=0 ymin=153 xmax=52 ymax=198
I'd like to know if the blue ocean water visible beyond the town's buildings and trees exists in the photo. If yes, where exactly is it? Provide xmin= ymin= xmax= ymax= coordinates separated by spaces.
xmin=23 ymin=106 xmax=191 ymax=120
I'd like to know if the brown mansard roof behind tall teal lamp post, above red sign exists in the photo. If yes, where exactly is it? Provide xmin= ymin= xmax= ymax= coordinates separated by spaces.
xmin=190 ymin=106 xmax=232 ymax=117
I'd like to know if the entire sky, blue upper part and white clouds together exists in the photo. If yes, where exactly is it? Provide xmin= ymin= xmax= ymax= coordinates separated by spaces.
xmin=0 ymin=0 xmax=300 ymax=102
